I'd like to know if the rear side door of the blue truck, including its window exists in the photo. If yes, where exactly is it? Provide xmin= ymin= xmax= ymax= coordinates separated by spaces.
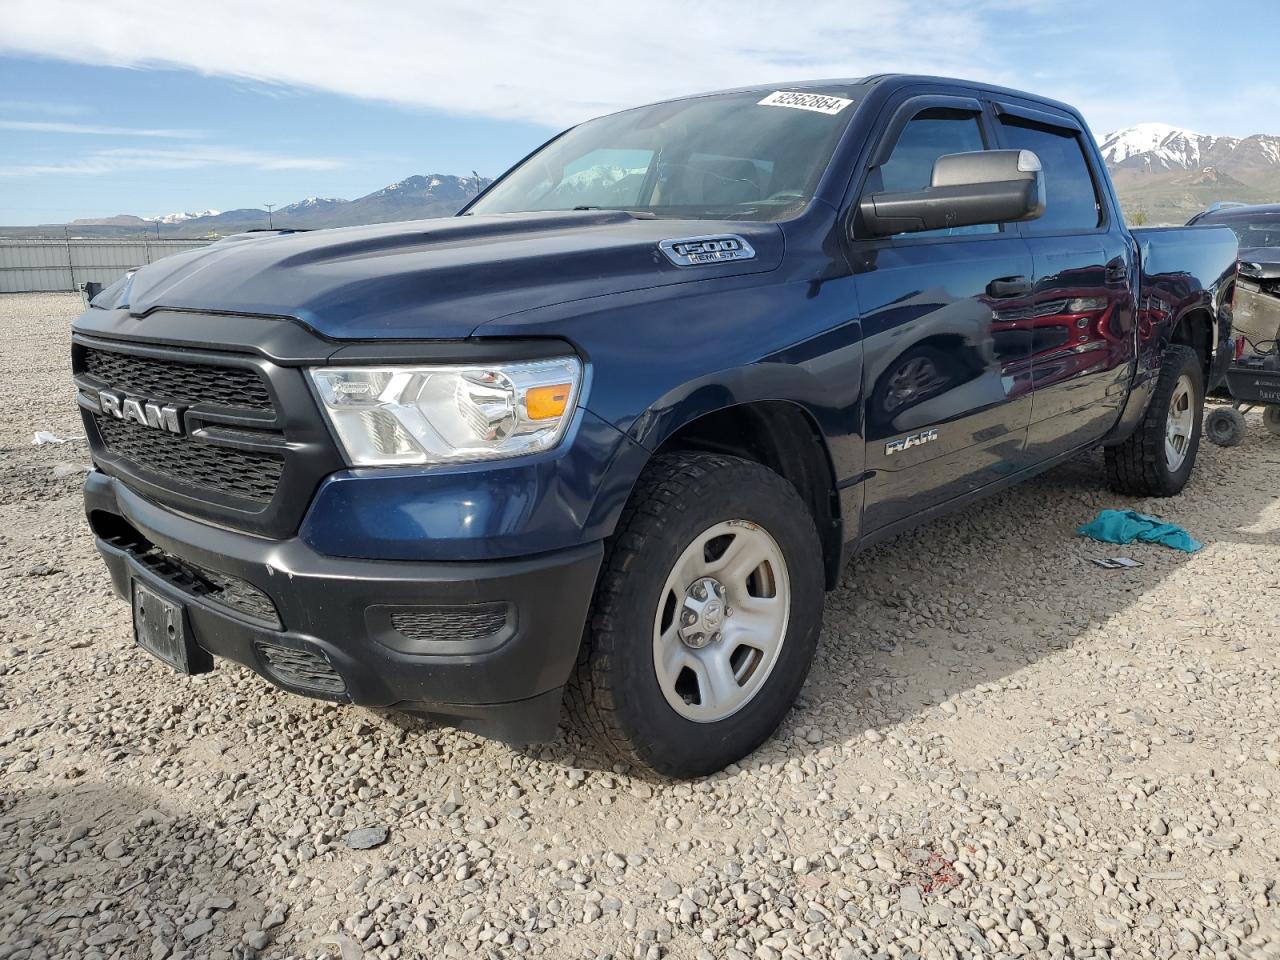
xmin=996 ymin=102 xmax=1135 ymax=462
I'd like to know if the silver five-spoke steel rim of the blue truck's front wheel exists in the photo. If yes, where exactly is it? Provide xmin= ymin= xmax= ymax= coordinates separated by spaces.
xmin=653 ymin=520 xmax=791 ymax=723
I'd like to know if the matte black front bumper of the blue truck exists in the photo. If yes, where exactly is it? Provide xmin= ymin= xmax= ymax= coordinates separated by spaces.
xmin=84 ymin=471 xmax=603 ymax=742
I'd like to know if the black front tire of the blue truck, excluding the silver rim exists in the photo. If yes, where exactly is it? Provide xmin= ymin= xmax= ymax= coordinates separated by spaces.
xmin=566 ymin=453 xmax=824 ymax=778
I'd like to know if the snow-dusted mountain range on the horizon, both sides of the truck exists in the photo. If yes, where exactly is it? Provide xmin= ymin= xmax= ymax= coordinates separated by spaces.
xmin=0 ymin=123 xmax=1280 ymax=238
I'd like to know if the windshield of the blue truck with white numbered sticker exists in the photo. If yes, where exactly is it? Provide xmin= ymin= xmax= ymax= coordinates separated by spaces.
xmin=467 ymin=84 xmax=860 ymax=220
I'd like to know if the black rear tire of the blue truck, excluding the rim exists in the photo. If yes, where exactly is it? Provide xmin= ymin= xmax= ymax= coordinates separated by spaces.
xmin=1105 ymin=343 xmax=1204 ymax=497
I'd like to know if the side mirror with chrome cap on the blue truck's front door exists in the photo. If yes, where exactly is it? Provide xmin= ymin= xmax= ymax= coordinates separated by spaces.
xmin=859 ymin=150 xmax=1044 ymax=237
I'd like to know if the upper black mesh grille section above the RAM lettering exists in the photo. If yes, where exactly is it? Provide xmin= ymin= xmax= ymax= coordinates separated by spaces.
xmin=81 ymin=347 xmax=271 ymax=411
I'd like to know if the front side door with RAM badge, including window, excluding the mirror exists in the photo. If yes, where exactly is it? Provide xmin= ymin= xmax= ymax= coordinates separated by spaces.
xmin=852 ymin=95 xmax=1032 ymax=532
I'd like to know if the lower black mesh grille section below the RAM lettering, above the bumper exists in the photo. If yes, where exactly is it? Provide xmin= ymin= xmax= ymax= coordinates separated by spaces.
xmin=93 ymin=415 xmax=284 ymax=503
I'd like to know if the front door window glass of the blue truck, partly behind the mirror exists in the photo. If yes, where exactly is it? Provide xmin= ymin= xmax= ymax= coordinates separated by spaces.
xmin=867 ymin=108 xmax=1000 ymax=237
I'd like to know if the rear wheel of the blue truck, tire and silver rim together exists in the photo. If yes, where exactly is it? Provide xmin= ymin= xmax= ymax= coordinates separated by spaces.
xmin=1106 ymin=343 xmax=1204 ymax=497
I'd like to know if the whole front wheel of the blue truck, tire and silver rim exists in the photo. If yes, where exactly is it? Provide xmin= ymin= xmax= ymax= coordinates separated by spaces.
xmin=568 ymin=453 xmax=823 ymax=777
